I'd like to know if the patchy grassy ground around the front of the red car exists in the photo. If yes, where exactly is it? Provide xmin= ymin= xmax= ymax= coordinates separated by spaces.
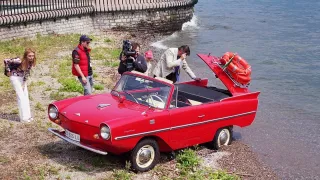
xmin=0 ymin=34 xmax=239 ymax=180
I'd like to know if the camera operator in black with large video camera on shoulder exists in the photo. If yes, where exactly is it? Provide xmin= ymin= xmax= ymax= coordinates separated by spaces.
xmin=118 ymin=41 xmax=147 ymax=75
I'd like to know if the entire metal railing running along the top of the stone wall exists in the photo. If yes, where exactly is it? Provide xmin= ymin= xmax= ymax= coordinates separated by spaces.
xmin=0 ymin=0 xmax=197 ymax=26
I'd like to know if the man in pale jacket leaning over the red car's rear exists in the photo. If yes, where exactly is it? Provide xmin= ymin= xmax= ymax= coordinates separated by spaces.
xmin=153 ymin=45 xmax=201 ymax=83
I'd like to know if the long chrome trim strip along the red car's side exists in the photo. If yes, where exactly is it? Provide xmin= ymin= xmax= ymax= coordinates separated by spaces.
xmin=114 ymin=111 xmax=256 ymax=140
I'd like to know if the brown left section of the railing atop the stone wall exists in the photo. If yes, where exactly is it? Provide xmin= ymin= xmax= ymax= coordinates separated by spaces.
xmin=0 ymin=0 xmax=94 ymax=26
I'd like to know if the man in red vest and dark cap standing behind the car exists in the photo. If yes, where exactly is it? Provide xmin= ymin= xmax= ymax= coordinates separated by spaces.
xmin=72 ymin=35 xmax=93 ymax=96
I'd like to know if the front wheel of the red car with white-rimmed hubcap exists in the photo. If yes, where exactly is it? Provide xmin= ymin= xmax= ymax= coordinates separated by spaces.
xmin=130 ymin=139 xmax=160 ymax=172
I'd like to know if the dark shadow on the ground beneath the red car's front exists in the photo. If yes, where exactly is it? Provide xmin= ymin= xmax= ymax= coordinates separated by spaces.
xmin=37 ymin=140 xmax=178 ymax=175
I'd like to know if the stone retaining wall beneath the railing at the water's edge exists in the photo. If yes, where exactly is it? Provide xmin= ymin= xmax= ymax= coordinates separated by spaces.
xmin=0 ymin=0 xmax=194 ymax=41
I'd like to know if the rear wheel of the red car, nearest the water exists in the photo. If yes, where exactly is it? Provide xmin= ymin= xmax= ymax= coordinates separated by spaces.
xmin=212 ymin=127 xmax=232 ymax=150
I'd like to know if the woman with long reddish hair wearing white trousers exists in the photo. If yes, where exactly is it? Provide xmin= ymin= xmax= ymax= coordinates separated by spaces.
xmin=5 ymin=48 xmax=36 ymax=122
